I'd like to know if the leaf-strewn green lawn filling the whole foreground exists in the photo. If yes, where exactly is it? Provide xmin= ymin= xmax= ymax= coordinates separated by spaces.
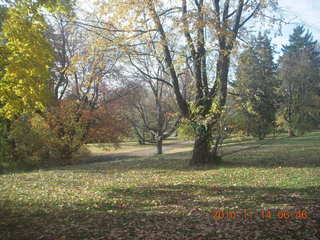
xmin=0 ymin=132 xmax=320 ymax=240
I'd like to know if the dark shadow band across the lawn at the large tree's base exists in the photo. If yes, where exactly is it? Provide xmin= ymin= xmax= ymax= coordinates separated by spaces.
xmin=49 ymin=144 xmax=320 ymax=174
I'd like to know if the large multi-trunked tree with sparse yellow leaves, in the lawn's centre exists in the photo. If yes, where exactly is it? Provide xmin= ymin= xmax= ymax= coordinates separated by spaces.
xmin=90 ymin=0 xmax=277 ymax=165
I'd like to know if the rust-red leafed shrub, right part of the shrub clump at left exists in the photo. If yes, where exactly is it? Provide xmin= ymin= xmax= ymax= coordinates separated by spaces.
xmin=46 ymin=101 xmax=128 ymax=159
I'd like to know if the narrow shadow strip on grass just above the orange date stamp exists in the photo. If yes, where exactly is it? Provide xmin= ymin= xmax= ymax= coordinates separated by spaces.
xmin=106 ymin=184 xmax=320 ymax=209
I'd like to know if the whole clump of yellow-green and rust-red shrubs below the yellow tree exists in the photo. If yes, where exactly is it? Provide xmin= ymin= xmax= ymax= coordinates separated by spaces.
xmin=8 ymin=101 xmax=129 ymax=166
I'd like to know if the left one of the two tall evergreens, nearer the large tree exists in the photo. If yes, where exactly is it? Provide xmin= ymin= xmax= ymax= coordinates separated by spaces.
xmin=235 ymin=33 xmax=277 ymax=139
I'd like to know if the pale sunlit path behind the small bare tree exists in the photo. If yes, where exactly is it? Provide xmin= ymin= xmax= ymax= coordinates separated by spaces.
xmin=81 ymin=141 xmax=192 ymax=163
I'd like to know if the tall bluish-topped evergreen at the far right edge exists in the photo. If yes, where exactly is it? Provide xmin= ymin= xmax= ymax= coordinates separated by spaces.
xmin=278 ymin=26 xmax=320 ymax=136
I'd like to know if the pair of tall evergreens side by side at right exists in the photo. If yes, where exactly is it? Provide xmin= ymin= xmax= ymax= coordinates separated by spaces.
xmin=231 ymin=26 xmax=320 ymax=139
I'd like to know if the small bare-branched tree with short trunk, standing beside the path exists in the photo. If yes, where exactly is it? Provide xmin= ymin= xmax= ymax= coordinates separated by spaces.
xmin=126 ymin=82 xmax=179 ymax=154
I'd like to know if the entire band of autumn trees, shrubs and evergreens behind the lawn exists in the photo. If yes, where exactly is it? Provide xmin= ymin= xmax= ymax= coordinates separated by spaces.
xmin=0 ymin=0 xmax=320 ymax=171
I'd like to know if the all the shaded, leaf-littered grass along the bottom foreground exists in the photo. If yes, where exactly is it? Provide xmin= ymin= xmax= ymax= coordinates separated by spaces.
xmin=0 ymin=184 xmax=320 ymax=240
